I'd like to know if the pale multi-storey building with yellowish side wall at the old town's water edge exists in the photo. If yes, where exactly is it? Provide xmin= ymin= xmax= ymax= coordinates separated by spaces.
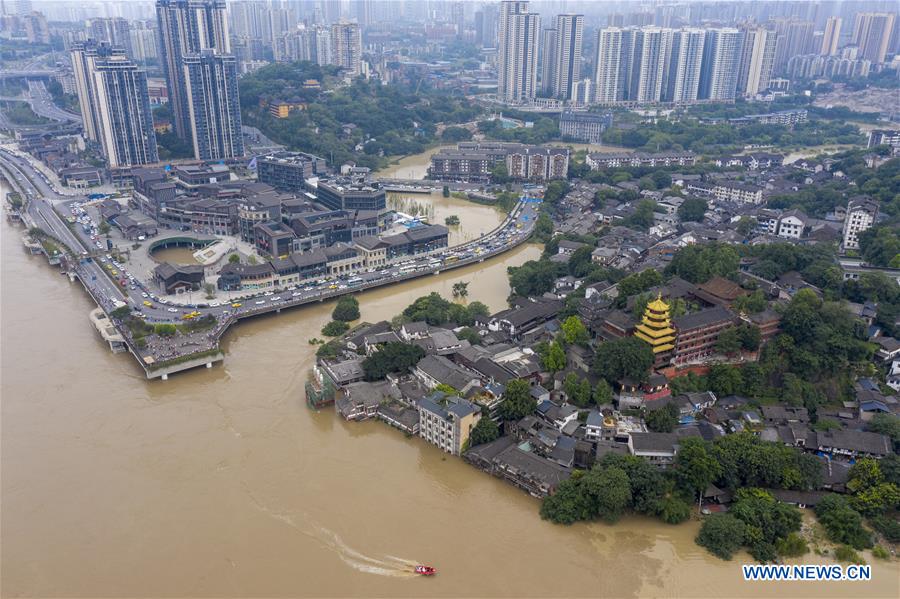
xmin=417 ymin=392 xmax=481 ymax=455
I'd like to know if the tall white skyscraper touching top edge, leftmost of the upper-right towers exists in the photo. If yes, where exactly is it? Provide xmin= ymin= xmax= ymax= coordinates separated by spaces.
xmin=497 ymin=0 xmax=541 ymax=102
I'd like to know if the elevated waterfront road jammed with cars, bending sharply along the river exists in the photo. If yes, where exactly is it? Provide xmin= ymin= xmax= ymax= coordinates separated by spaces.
xmin=0 ymin=149 xmax=540 ymax=376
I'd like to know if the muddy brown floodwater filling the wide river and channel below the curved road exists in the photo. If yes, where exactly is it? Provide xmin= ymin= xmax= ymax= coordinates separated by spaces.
xmin=0 ymin=176 xmax=898 ymax=598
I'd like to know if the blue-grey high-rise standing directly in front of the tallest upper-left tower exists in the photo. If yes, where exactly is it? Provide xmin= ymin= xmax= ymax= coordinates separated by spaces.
xmin=183 ymin=50 xmax=244 ymax=160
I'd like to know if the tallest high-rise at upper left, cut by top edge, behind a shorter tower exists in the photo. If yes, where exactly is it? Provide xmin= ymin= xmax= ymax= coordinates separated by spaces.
xmin=156 ymin=0 xmax=231 ymax=139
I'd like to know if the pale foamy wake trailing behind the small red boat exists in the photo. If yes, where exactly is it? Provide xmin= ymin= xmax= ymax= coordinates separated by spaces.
xmin=248 ymin=491 xmax=422 ymax=578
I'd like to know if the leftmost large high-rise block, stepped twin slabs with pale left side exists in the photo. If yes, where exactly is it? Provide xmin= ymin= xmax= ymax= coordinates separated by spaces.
xmin=71 ymin=40 xmax=159 ymax=168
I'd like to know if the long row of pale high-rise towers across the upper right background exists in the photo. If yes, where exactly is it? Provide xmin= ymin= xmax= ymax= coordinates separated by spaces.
xmin=492 ymin=0 xmax=896 ymax=105
